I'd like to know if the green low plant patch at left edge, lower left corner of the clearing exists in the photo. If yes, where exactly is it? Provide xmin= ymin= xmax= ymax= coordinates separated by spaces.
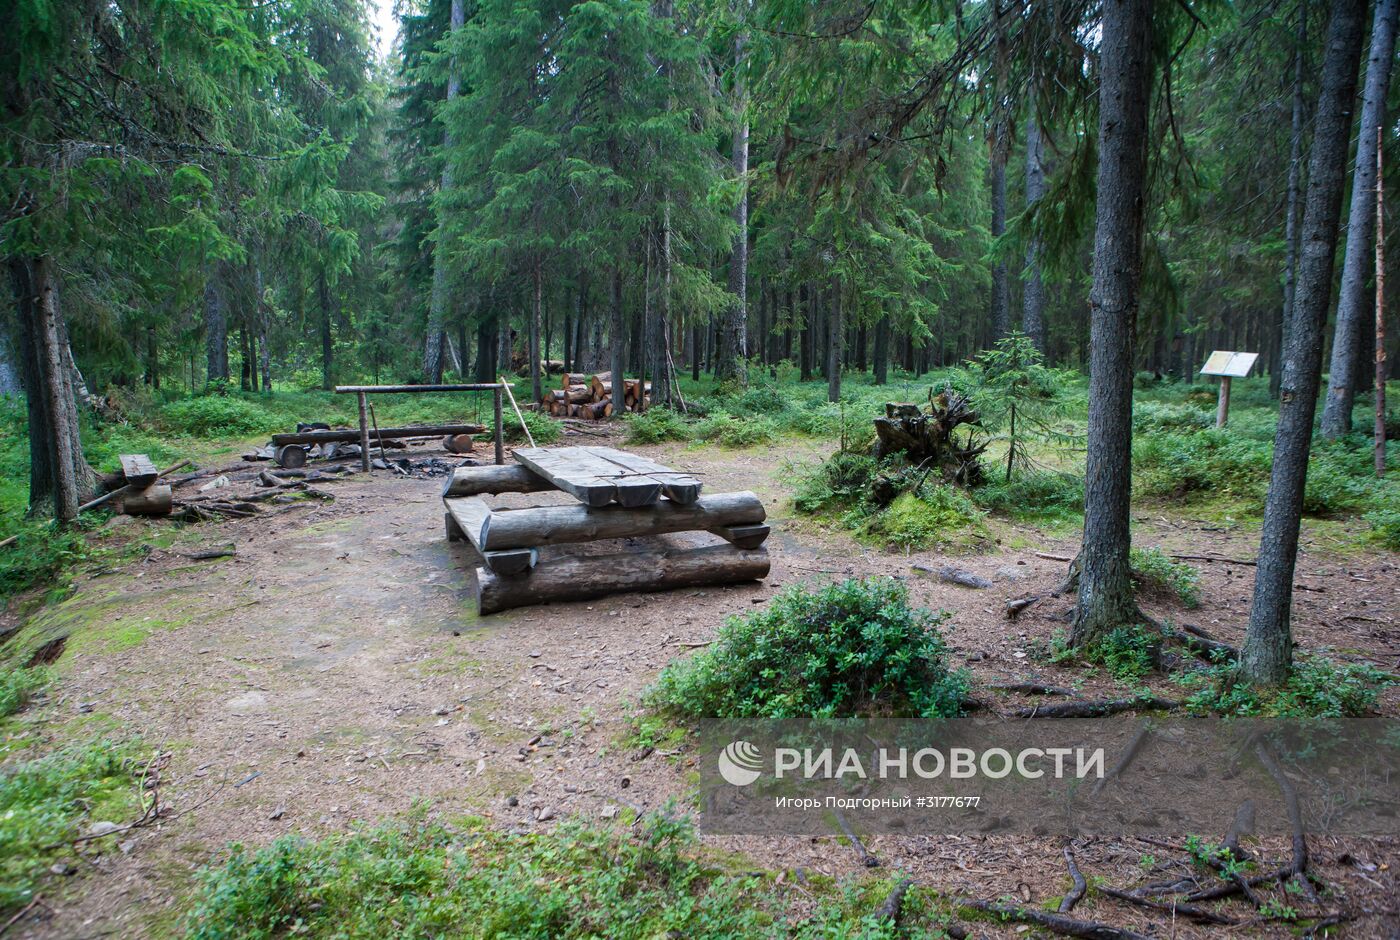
xmin=0 ymin=741 xmax=140 ymax=911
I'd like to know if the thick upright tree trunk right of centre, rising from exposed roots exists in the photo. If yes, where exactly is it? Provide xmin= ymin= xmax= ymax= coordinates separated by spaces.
xmin=1070 ymin=0 xmax=1154 ymax=646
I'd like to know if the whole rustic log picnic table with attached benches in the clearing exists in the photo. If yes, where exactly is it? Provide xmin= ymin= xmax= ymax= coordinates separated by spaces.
xmin=442 ymin=447 xmax=769 ymax=614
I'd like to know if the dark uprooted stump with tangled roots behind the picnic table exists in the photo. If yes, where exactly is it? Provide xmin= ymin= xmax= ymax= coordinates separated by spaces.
xmin=875 ymin=389 xmax=987 ymax=486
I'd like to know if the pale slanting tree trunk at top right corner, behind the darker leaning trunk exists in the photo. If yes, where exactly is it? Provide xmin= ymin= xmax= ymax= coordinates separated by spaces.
xmin=1309 ymin=0 xmax=1400 ymax=438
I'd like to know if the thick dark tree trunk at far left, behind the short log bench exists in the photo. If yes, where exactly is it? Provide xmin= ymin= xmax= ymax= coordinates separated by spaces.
xmin=10 ymin=255 xmax=95 ymax=523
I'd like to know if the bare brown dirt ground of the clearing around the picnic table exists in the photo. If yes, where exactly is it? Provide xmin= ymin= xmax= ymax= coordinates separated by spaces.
xmin=5 ymin=438 xmax=1400 ymax=937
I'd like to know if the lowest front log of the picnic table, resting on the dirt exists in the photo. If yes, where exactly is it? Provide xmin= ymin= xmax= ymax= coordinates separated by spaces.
xmin=476 ymin=543 xmax=769 ymax=614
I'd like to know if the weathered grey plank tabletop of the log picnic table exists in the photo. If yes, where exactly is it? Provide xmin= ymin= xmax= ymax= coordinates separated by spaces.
xmin=515 ymin=447 xmax=700 ymax=507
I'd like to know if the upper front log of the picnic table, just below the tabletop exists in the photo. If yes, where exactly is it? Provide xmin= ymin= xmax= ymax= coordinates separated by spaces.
xmin=444 ymin=493 xmax=766 ymax=552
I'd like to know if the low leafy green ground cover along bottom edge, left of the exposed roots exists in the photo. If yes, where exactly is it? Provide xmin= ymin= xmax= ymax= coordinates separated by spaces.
xmin=177 ymin=813 xmax=939 ymax=940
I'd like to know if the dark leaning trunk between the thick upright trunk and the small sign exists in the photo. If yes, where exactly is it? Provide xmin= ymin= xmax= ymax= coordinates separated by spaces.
xmin=1240 ymin=0 xmax=1375 ymax=685
